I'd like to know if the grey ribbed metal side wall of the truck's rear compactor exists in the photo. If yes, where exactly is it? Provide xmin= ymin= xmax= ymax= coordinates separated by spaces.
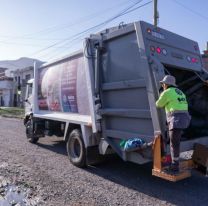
xmin=94 ymin=25 xmax=159 ymax=163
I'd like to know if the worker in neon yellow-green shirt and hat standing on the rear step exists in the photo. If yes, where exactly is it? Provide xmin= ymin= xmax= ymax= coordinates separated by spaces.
xmin=156 ymin=75 xmax=191 ymax=173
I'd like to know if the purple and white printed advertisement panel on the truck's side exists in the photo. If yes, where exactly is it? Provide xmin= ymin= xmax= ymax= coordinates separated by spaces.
xmin=38 ymin=57 xmax=90 ymax=115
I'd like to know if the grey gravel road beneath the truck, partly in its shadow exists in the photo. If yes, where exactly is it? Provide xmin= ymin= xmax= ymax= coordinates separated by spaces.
xmin=0 ymin=117 xmax=208 ymax=206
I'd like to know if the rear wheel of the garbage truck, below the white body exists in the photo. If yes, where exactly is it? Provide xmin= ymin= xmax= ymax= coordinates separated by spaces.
xmin=66 ymin=129 xmax=86 ymax=168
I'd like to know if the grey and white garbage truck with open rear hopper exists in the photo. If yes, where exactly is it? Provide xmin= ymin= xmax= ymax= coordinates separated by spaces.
xmin=24 ymin=21 xmax=208 ymax=179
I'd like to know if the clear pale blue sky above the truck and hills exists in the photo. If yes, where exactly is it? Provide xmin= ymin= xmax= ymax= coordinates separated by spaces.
xmin=0 ymin=0 xmax=208 ymax=61
